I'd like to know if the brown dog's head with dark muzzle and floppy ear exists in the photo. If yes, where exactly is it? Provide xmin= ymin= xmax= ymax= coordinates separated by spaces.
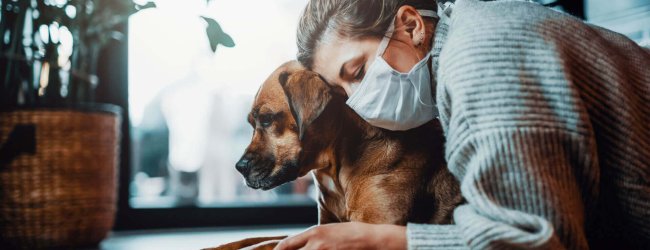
xmin=236 ymin=62 xmax=332 ymax=190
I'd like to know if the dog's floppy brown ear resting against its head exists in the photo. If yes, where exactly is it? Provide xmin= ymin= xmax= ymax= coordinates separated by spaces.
xmin=279 ymin=70 xmax=332 ymax=139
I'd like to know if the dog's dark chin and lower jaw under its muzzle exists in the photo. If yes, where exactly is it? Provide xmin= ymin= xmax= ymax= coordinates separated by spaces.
xmin=246 ymin=164 xmax=299 ymax=190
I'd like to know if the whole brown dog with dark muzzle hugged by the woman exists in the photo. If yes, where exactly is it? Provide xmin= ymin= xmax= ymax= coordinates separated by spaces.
xmin=208 ymin=62 xmax=463 ymax=249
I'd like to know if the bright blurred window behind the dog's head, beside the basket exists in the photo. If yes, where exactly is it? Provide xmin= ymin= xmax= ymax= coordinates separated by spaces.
xmin=118 ymin=0 xmax=316 ymax=230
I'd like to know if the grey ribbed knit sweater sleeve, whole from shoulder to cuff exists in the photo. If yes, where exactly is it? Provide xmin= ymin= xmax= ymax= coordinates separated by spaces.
xmin=407 ymin=1 xmax=599 ymax=249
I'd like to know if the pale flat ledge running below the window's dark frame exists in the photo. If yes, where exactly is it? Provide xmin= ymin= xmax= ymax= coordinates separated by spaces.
xmin=100 ymin=225 xmax=309 ymax=250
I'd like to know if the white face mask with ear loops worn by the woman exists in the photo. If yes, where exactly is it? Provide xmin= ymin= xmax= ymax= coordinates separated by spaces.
xmin=346 ymin=11 xmax=437 ymax=130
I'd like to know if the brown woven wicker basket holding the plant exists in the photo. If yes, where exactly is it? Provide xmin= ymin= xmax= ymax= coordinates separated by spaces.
xmin=0 ymin=105 xmax=121 ymax=249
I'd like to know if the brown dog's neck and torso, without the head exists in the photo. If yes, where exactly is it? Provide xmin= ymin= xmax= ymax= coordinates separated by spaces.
xmin=299 ymin=98 xmax=450 ymax=223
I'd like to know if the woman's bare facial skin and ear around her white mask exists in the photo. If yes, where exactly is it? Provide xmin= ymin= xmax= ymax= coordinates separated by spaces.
xmin=312 ymin=6 xmax=430 ymax=96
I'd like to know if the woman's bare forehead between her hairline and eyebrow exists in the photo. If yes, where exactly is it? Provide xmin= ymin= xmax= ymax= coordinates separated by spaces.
xmin=313 ymin=38 xmax=381 ymax=83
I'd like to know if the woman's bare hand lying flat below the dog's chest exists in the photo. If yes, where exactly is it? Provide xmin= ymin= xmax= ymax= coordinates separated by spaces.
xmin=275 ymin=222 xmax=406 ymax=250
